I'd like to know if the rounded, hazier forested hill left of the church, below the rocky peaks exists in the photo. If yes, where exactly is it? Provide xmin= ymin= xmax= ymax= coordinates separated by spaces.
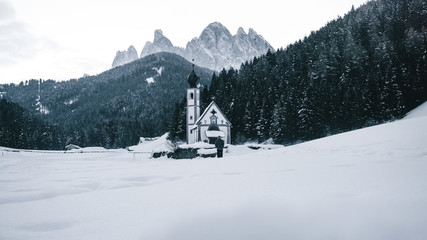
xmin=2 ymin=53 xmax=212 ymax=148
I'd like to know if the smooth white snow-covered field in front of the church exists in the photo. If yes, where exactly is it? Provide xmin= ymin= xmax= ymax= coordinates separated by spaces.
xmin=0 ymin=103 xmax=427 ymax=240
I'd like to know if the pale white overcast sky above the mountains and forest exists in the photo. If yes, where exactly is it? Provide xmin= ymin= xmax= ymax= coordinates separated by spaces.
xmin=0 ymin=0 xmax=366 ymax=83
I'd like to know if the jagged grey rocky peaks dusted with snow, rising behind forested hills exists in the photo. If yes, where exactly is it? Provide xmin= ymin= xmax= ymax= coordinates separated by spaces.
xmin=113 ymin=22 xmax=274 ymax=70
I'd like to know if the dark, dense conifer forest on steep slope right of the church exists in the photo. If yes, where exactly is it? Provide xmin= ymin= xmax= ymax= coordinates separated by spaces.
xmin=171 ymin=0 xmax=427 ymax=144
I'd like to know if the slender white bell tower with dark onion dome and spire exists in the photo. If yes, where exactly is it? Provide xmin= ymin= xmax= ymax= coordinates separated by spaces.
xmin=186 ymin=64 xmax=200 ymax=144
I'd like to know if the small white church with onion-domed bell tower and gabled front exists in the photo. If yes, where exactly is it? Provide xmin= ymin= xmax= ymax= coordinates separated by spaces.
xmin=186 ymin=64 xmax=231 ymax=144
